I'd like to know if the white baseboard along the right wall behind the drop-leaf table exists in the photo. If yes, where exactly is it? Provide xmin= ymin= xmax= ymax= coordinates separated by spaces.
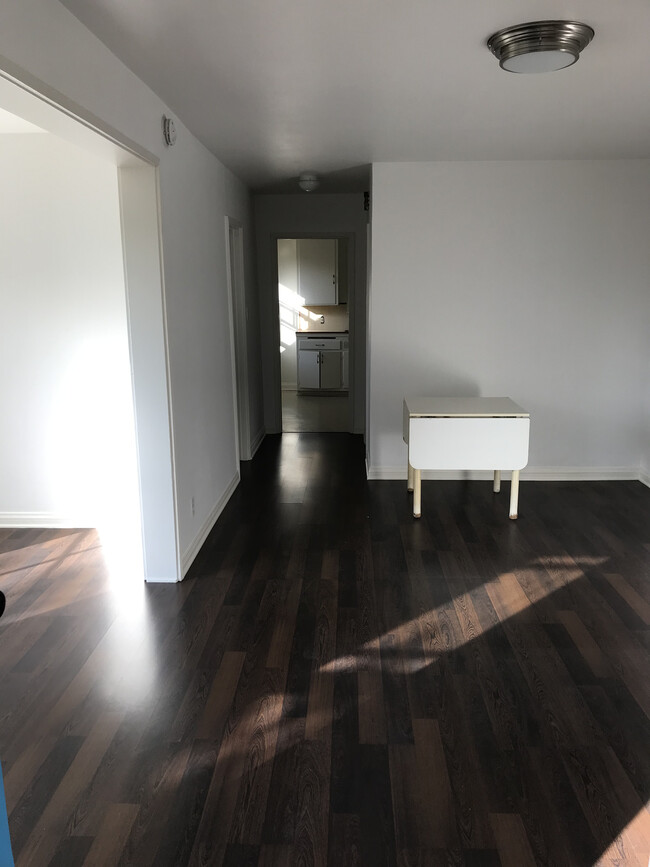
xmin=366 ymin=464 xmax=643 ymax=482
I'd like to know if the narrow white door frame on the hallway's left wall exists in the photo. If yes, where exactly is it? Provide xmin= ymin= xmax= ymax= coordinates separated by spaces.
xmin=226 ymin=217 xmax=253 ymax=464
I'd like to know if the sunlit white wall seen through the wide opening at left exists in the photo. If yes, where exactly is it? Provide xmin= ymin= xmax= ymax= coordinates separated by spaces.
xmin=0 ymin=135 xmax=139 ymax=543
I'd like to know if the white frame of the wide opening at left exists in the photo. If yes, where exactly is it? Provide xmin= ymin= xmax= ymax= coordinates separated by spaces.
xmin=0 ymin=58 xmax=181 ymax=582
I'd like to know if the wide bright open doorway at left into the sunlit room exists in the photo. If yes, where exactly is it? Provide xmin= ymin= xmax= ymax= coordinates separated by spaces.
xmin=0 ymin=73 xmax=179 ymax=585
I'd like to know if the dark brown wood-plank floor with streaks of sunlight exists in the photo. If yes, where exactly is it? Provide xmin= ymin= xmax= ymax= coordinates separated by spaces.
xmin=0 ymin=434 xmax=650 ymax=867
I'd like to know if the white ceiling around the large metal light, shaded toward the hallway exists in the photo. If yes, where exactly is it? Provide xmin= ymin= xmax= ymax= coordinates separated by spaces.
xmin=61 ymin=0 xmax=650 ymax=192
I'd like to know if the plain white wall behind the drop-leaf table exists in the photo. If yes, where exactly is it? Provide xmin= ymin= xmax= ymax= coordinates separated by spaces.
xmin=369 ymin=161 xmax=650 ymax=477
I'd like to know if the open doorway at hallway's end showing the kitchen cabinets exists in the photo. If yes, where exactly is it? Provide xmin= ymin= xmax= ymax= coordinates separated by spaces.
xmin=277 ymin=237 xmax=351 ymax=432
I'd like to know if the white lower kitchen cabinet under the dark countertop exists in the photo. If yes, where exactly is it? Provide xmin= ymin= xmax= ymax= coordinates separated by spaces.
xmin=296 ymin=333 xmax=348 ymax=392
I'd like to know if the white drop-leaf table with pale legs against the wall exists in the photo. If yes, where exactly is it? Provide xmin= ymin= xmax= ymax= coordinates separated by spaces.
xmin=404 ymin=397 xmax=530 ymax=520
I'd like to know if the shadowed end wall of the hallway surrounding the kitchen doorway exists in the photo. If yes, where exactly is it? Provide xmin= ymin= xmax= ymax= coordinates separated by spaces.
xmin=254 ymin=193 xmax=368 ymax=433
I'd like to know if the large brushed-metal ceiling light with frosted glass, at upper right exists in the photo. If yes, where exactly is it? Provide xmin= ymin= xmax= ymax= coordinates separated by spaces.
xmin=488 ymin=21 xmax=594 ymax=72
